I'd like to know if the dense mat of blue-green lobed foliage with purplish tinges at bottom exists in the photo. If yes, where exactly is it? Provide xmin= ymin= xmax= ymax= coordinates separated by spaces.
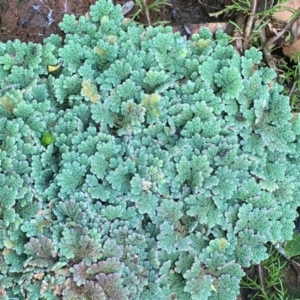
xmin=0 ymin=0 xmax=300 ymax=300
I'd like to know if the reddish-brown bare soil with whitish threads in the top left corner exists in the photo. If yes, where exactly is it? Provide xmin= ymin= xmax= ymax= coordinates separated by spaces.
xmin=0 ymin=0 xmax=95 ymax=42
